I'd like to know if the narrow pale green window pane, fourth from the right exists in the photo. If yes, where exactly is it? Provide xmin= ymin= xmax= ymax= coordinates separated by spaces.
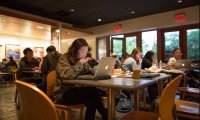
xmin=126 ymin=36 xmax=137 ymax=54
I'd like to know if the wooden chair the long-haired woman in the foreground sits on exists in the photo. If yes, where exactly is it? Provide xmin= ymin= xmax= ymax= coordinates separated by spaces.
xmin=47 ymin=71 xmax=85 ymax=120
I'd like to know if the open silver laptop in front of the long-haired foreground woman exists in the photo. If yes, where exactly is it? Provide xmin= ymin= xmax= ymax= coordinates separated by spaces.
xmin=77 ymin=57 xmax=116 ymax=80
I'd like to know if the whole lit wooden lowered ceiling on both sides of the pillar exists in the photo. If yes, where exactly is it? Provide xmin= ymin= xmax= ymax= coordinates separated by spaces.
xmin=0 ymin=14 xmax=91 ymax=40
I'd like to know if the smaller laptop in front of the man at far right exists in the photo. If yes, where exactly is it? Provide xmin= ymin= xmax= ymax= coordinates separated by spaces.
xmin=175 ymin=60 xmax=192 ymax=69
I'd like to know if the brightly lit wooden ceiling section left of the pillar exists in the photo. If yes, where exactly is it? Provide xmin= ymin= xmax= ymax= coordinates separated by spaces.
xmin=0 ymin=15 xmax=51 ymax=40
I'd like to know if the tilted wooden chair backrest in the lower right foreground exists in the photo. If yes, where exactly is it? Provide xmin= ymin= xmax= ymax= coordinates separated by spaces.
xmin=159 ymin=75 xmax=182 ymax=120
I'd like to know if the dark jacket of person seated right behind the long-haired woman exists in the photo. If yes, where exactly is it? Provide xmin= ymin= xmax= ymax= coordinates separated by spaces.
xmin=41 ymin=51 xmax=61 ymax=80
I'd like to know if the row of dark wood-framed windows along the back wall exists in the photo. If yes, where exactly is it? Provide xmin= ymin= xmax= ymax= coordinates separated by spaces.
xmin=96 ymin=24 xmax=200 ymax=63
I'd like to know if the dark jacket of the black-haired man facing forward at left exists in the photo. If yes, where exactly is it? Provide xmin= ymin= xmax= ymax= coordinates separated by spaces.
xmin=17 ymin=57 xmax=39 ymax=79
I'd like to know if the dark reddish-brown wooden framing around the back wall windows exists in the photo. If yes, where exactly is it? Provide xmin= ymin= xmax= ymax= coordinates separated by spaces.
xmin=96 ymin=23 xmax=200 ymax=62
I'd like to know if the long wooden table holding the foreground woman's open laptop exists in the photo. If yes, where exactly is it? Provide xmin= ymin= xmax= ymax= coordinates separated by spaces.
xmin=63 ymin=74 xmax=171 ymax=120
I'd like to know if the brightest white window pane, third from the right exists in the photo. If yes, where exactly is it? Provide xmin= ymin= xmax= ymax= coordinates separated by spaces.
xmin=142 ymin=30 xmax=157 ymax=58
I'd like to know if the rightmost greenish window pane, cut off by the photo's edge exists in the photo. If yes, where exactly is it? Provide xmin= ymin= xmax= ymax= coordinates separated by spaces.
xmin=187 ymin=29 xmax=200 ymax=60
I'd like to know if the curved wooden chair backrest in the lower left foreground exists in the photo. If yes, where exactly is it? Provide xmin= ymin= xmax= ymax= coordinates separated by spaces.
xmin=16 ymin=80 xmax=58 ymax=120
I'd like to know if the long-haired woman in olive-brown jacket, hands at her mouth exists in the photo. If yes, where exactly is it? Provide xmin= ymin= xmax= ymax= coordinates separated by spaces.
xmin=56 ymin=38 xmax=108 ymax=120
